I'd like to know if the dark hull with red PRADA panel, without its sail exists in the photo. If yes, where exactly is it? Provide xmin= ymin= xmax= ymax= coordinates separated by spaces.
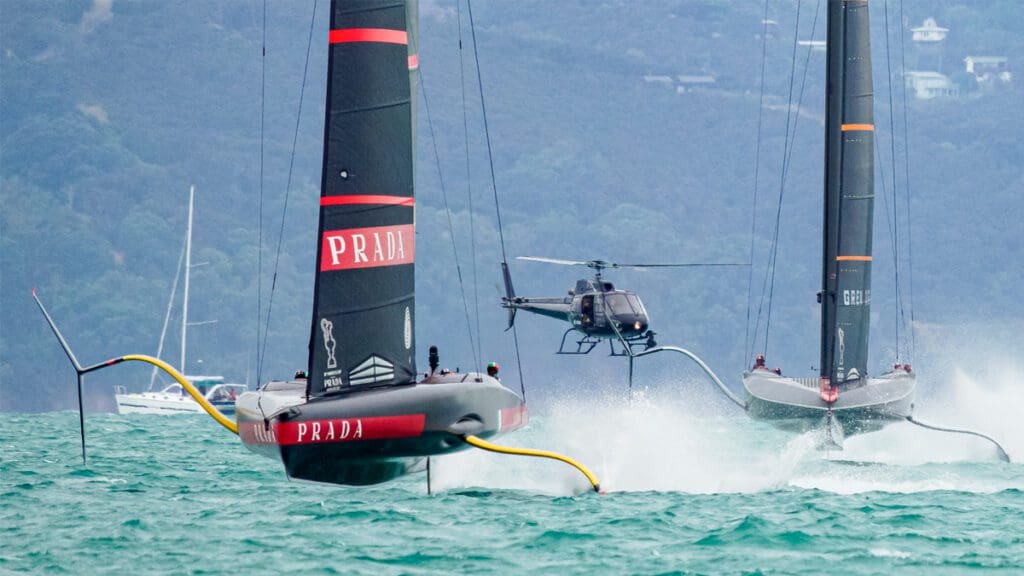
xmin=237 ymin=374 xmax=526 ymax=486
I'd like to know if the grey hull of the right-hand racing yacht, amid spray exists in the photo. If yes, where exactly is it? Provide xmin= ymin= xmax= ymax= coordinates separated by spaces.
xmin=743 ymin=370 xmax=916 ymax=437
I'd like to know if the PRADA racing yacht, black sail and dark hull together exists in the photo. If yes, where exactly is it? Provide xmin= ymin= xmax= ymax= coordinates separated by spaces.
xmin=237 ymin=0 xmax=526 ymax=485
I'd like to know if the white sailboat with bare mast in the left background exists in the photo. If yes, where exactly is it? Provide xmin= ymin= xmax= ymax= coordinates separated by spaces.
xmin=114 ymin=187 xmax=249 ymax=414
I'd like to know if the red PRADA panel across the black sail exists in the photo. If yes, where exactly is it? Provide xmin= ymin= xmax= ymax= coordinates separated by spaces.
xmin=321 ymin=224 xmax=416 ymax=272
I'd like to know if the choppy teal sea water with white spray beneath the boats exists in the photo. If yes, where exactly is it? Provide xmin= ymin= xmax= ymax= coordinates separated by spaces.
xmin=0 ymin=381 xmax=1024 ymax=574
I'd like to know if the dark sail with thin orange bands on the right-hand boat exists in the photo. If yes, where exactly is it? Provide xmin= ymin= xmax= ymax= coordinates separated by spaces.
xmin=820 ymin=0 xmax=874 ymax=384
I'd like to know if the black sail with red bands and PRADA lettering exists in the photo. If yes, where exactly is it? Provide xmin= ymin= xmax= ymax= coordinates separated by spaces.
xmin=308 ymin=0 xmax=416 ymax=397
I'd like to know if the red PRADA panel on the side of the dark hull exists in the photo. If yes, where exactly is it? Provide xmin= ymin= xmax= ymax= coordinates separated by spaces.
xmin=273 ymin=414 xmax=427 ymax=446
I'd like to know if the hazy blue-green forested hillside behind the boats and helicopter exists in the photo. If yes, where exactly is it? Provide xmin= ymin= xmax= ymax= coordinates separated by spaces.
xmin=0 ymin=0 xmax=1024 ymax=410
